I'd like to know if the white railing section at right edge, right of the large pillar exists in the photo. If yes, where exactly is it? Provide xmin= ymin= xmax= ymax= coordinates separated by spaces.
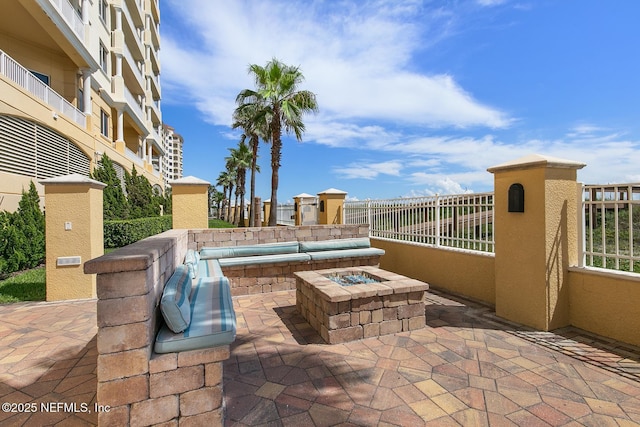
xmin=580 ymin=184 xmax=640 ymax=273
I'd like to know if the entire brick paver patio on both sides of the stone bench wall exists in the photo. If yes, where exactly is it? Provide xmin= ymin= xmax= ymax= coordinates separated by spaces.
xmin=0 ymin=291 xmax=640 ymax=426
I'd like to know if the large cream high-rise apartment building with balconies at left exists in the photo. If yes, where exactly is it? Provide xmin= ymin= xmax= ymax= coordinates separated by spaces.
xmin=0 ymin=0 xmax=165 ymax=211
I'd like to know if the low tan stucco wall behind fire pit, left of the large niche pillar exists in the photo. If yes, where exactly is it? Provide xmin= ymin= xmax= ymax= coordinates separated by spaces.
xmin=371 ymin=238 xmax=495 ymax=305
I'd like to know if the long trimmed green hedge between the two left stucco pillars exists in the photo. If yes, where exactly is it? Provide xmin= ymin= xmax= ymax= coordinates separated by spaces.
xmin=104 ymin=215 xmax=172 ymax=248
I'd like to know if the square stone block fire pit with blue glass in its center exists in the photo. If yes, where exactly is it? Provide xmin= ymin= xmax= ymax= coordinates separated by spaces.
xmin=294 ymin=266 xmax=429 ymax=344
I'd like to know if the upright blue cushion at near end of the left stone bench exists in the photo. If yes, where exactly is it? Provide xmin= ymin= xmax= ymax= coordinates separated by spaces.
xmin=160 ymin=265 xmax=191 ymax=333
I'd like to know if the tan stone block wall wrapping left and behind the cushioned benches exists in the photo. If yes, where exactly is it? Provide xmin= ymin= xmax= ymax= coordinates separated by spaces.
xmin=84 ymin=225 xmax=376 ymax=426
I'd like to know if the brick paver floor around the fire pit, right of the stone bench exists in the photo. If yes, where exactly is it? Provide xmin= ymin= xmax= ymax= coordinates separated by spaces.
xmin=224 ymin=291 xmax=640 ymax=426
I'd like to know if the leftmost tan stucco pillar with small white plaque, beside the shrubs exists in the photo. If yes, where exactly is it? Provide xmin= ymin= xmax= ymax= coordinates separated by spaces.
xmin=40 ymin=174 xmax=105 ymax=301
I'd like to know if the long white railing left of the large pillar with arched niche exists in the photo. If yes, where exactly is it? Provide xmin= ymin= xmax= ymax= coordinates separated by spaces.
xmin=344 ymin=193 xmax=494 ymax=252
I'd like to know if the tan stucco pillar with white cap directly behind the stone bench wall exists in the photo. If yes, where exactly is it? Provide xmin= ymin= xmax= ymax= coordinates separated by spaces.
xmin=169 ymin=176 xmax=211 ymax=229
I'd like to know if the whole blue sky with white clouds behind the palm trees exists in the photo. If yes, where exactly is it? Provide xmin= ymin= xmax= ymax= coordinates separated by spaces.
xmin=160 ymin=0 xmax=640 ymax=202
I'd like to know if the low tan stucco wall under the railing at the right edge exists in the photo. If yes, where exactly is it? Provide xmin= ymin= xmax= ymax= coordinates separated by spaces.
xmin=569 ymin=268 xmax=640 ymax=346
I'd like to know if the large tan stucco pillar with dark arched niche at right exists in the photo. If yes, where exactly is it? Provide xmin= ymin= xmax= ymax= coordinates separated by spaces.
xmin=488 ymin=154 xmax=585 ymax=331
